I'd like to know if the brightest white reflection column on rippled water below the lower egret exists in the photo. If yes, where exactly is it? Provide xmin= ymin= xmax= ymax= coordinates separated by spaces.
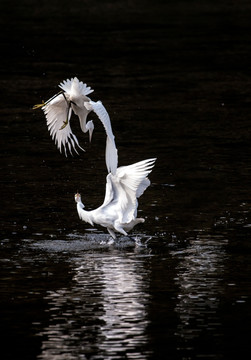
xmin=98 ymin=258 xmax=148 ymax=359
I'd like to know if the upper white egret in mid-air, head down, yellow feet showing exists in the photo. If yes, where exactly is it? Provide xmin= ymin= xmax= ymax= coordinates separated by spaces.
xmin=33 ymin=77 xmax=118 ymax=174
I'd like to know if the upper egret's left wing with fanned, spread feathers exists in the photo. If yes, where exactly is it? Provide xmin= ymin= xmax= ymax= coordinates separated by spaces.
xmin=42 ymin=94 xmax=84 ymax=156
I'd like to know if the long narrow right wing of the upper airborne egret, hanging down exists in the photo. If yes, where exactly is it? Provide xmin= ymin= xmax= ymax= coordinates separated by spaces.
xmin=85 ymin=100 xmax=118 ymax=174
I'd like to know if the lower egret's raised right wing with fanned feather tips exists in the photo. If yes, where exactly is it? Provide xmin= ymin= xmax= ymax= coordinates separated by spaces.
xmin=112 ymin=159 xmax=156 ymax=223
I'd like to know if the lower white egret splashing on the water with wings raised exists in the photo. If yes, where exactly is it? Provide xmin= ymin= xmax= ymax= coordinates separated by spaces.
xmin=75 ymin=158 xmax=156 ymax=239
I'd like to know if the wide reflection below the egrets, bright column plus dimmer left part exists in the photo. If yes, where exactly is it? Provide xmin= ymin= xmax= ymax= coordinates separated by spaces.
xmin=39 ymin=250 xmax=149 ymax=360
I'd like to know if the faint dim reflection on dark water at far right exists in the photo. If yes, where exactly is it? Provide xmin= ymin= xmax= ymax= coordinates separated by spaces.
xmin=173 ymin=235 xmax=227 ymax=351
